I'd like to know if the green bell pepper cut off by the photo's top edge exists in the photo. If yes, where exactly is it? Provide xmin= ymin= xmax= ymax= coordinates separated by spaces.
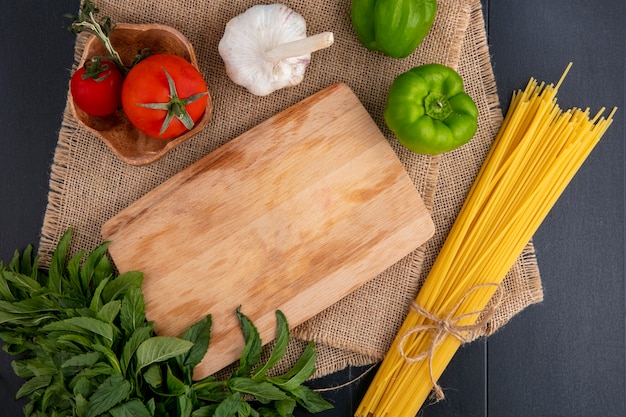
xmin=350 ymin=0 xmax=437 ymax=58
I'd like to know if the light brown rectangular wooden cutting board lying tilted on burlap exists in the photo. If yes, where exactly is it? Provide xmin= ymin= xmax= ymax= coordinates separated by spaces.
xmin=102 ymin=84 xmax=434 ymax=378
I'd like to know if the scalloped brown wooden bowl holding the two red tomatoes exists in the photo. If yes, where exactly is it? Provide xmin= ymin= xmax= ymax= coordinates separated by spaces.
xmin=69 ymin=23 xmax=213 ymax=166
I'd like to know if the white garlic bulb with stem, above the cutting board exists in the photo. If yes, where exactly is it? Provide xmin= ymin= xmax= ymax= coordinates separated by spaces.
xmin=218 ymin=4 xmax=333 ymax=96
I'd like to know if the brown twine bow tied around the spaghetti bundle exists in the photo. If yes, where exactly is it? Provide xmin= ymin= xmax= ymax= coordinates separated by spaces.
xmin=398 ymin=283 xmax=503 ymax=401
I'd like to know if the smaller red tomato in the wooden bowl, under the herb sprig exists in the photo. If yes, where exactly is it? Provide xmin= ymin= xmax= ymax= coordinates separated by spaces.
xmin=70 ymin=58 xmax=124 ymax=116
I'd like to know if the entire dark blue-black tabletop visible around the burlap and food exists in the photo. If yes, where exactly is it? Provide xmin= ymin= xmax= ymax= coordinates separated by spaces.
xmin=0 ymin=0 xmax=626 ymax=417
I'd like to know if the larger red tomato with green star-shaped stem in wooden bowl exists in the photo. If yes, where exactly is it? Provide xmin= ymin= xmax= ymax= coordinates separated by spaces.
xmin=122 ymin=54 xmax=208 ymax=139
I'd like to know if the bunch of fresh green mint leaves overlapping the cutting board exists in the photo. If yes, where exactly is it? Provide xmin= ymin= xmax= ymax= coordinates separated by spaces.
xmin=0 ymin=229 xmax=332 ymax=417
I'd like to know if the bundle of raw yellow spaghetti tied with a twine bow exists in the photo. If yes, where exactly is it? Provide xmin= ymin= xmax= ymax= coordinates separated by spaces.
xmin=355 ymin=63 xmax=615 ymax=417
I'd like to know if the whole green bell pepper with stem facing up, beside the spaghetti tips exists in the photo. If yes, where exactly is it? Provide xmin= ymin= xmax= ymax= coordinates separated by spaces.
xmin=384 ymin=64 xmax=478 ymax=155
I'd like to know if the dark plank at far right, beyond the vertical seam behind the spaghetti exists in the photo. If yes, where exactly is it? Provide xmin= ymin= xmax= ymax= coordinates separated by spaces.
xmin=481 ymin=0 xmax=626 ymax=417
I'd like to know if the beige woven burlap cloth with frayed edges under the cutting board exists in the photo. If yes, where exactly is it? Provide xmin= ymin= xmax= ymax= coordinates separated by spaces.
xmin=39 ymin=0 xmax=542 ymax=376
